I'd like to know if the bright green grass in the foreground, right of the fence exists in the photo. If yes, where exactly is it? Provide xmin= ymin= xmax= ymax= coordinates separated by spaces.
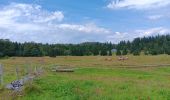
xmin=21 ymin=68 xmax=170 ymax=100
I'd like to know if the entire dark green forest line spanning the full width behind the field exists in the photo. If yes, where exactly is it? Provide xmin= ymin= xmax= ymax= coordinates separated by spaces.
xmin=0 ymin=35 xmax=170 ymax=57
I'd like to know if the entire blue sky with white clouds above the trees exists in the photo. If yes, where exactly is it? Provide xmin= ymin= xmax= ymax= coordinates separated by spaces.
xmin=0 ymin=0 xmax=170 ymax=43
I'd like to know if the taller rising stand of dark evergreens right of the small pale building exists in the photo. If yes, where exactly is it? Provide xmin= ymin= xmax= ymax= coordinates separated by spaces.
xmin=116 ymin=35 xmax=170 ymax=55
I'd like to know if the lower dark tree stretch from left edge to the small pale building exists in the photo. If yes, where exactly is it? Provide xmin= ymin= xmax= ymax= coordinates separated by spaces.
xmin=0 ymin=39 xmax=116 ymax=57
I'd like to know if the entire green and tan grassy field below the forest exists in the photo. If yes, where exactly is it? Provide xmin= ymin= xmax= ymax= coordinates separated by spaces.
xmin=0 ymin=55 xmax=170 ymax=100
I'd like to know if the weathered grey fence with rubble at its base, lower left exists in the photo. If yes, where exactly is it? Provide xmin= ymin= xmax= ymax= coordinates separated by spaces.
xmin=0 ymin=64 xmax=43 ymax=91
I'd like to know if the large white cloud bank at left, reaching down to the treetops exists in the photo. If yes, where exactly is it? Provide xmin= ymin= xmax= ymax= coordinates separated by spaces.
xmin=0 ymin=3 xmax=111 ymax=43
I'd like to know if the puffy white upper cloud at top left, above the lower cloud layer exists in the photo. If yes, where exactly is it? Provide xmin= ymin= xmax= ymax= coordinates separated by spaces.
xmin=0 ymin=3 xmax=64 ymax=23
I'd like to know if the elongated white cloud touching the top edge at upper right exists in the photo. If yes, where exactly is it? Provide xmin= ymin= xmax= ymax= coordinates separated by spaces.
xmin=107 ymin=0 xmax=170 ymax=10
